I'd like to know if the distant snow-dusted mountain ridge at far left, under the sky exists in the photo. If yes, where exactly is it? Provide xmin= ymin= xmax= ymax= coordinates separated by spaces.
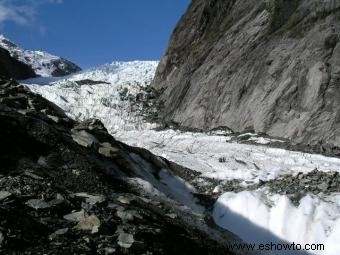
xmin=0 ymin=35 xmax=81 ymax=77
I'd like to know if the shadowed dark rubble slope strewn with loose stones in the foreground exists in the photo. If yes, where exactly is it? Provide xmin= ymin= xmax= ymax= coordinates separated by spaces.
xmin=0 ymin=80 xmax=239 ymax=254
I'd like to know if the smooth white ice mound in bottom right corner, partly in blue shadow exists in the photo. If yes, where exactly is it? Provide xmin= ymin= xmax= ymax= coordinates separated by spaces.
xmin=213 ymin=190 xmax=340 ymax=255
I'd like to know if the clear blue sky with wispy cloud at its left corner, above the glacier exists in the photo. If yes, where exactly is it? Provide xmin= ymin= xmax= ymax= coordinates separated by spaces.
xmin=0 ymin=0 xmax=190 ymax=68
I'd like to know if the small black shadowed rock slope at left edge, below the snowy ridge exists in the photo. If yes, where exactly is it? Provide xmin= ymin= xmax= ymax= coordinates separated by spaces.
xmin=0 ymin=47 xmax=37 ymax=80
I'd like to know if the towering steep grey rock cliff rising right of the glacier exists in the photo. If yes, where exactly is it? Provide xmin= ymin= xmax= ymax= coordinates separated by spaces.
xmin=153 ymin=0 xmax=340 ymax=147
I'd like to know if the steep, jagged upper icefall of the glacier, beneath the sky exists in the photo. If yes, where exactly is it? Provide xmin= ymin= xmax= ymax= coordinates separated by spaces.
xmin=22 ymin=61 xmax=158 ymax=134
